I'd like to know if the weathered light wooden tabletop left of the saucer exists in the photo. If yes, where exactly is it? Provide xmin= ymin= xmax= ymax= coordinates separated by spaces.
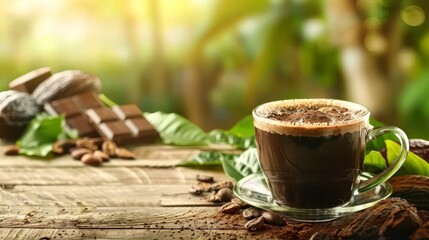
xmin=0 ymin=143 xmax=280 ymax=239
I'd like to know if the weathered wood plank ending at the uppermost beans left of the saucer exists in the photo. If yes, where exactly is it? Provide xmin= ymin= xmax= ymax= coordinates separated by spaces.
xmin=0 ymin=166 xmax=227 ymax=186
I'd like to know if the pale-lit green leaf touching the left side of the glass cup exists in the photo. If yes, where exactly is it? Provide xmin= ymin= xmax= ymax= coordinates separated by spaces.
xmin=222 ymin=148 xmax=261 ymax=181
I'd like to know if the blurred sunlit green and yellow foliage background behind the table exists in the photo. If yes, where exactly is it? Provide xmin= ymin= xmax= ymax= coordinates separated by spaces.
xmin=0 ymin=0 xmax=429 ymax=139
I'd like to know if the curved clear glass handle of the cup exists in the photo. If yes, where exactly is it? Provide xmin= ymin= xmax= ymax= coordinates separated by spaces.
xmin=358 ymin=126 xmax=410 ymax=192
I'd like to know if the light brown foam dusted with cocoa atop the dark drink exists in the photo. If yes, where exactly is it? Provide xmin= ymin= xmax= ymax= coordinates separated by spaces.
xmin=254 ymin=99 xmax=369 ymax=136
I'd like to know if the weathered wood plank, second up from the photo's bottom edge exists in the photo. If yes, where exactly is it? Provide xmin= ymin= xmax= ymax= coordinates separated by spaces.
xmin=0 ymin=206 xmax=237 ymax=230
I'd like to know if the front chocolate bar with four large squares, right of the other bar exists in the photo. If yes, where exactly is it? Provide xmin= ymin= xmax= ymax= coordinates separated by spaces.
xmin=86 ymin=105 xmax=159 ymax=145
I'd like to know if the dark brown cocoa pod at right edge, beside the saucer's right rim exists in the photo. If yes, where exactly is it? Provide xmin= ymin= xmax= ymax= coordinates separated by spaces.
xmin=389 ymin=175 xmax=429 ymax=210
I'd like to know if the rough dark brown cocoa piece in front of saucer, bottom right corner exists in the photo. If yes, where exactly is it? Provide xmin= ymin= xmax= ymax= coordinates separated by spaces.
xmin=338 ymin=198 xmax=422 ymax=239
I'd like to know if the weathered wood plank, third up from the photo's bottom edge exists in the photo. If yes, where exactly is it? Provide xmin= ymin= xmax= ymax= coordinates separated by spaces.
xmin=0 ymin=184 xmax=219 ymax=207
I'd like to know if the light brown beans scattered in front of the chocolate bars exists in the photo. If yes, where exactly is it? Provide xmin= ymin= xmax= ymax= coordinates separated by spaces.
xmin=4 ymin=138 xmax=135 ymax=166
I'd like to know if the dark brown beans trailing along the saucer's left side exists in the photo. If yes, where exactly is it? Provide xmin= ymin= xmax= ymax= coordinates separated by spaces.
xmin=188 ymin=175 xmax=286 ymax=232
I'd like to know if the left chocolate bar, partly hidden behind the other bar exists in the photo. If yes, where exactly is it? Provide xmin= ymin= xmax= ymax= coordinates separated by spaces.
xmin=44 ymin=92 xmax=104 ymax=137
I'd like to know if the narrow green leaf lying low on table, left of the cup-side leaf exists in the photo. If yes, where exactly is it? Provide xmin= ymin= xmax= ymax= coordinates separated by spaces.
xmin=176 ymin=151 xmax=238 ymax=167
